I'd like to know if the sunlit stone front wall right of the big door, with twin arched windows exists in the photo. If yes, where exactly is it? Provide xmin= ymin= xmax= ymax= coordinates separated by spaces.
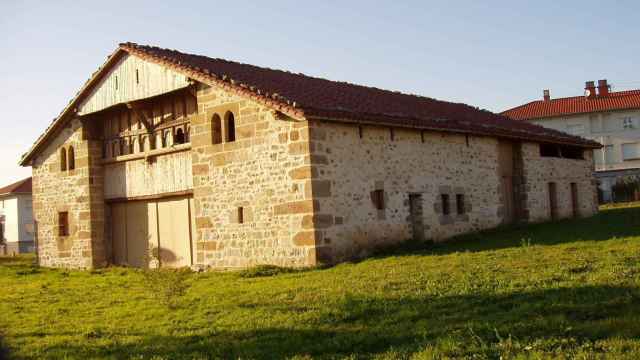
xmin=191 ymin=85 xmax=316 ymax=268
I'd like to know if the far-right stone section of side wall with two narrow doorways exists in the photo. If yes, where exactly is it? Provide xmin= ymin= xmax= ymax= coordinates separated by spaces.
xmin=522 ymin=143 xmax=598 ymax=222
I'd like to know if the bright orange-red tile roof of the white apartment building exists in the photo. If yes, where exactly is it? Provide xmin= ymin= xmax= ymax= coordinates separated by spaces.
xmin=502 ymin=90 xmax=640 ymax=120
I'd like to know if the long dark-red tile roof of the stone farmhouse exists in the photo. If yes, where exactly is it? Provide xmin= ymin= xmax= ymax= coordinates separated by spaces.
xmin=120 ymin=43 xmax=600 ymax=147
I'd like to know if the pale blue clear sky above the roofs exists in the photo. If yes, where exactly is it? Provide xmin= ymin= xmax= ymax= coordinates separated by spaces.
xmin=0 ymin=0 xmax=640 ymax=185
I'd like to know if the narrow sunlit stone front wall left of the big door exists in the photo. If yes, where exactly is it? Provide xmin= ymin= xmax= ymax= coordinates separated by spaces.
xmin=32 ymin=119 xmax=105 ymax=268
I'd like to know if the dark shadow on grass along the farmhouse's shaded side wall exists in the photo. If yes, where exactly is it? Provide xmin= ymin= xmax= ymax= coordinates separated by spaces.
xmin=376 ymin=207 xmax=640 ymax=257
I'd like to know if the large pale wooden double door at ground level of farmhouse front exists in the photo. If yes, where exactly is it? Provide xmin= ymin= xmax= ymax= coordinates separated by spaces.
xmin=111 ymin=197 xmax=195 ymax=268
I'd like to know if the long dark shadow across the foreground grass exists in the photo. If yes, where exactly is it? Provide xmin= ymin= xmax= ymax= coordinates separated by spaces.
xmin=32 ymin=286 xmax=640 ymax=359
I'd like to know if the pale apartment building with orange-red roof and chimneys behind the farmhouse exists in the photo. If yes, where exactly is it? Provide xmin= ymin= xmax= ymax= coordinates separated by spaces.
xmin=502 ymin=80 xmax=640 ymax=202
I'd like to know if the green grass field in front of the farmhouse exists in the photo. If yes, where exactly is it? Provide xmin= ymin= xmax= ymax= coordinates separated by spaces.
xmin=0 ymin=205 xmax=640 ymax=359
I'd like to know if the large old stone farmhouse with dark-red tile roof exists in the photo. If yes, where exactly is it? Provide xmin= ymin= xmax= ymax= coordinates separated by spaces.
xmin=21 ymin=43 xmax=600 ymax=268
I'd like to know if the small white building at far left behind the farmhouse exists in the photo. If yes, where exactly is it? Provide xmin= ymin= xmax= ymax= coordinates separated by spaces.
xmin=0 ymin=178 xmax=34 ymax=255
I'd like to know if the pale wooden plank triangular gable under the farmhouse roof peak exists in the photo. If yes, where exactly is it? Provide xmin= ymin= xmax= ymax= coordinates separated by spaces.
xmin=78 ymin=54 xmax=189 ymax=115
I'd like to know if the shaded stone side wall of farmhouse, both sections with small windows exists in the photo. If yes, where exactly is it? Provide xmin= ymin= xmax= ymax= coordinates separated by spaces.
xmin=310 ymin=122 xmax=597 ymax=262
